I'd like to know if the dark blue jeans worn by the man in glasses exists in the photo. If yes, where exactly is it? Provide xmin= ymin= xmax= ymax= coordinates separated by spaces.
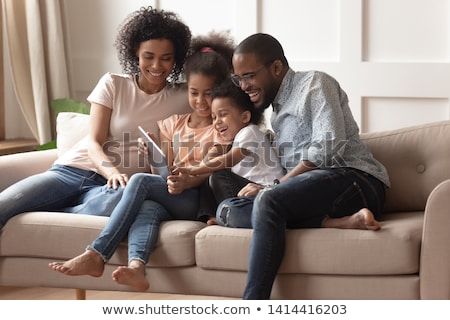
xmin=217 ymin=168 xmax=385 ymax=299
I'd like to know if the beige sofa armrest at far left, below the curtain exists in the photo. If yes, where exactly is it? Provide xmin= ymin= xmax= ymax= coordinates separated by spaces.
xmin=0 ymin=149 xmax=58 ymax=191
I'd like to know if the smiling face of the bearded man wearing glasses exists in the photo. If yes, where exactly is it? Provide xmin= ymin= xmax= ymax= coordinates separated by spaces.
xmin=233 ymin=53 xmax=279 ymax=109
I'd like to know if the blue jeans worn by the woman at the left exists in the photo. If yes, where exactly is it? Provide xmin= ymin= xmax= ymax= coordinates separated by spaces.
xmin=0 ymin=165 xmax=121 ymax=229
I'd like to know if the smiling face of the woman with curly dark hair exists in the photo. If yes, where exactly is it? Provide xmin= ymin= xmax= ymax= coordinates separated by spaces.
xmin=136 ymin=39 xmax=175 ymax=93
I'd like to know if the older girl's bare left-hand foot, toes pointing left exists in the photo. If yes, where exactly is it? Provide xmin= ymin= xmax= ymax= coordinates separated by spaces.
xmin=48 ymin=250 xmax=105 ymax=277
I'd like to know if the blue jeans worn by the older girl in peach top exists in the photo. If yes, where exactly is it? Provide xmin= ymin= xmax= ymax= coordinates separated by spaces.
xmin=88 ymin=173 xmax=199 ymax=264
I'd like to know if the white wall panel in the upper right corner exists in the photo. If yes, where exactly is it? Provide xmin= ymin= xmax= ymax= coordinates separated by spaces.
xmin=364 ymin=0 xmax=450 ymax=62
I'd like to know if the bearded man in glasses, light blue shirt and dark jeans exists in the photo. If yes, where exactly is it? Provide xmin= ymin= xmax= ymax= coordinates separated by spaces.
xmin=226 ymin=34 xmax=389 ymax=299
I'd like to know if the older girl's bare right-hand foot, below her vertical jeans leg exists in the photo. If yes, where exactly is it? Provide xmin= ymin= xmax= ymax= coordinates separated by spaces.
xmin=112 ymin=260 xmax=150 ymax=292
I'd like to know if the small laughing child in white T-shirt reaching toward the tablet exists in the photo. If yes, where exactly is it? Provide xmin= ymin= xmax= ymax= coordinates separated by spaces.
xmin=176 ymin=80 xmax=284 ymax=227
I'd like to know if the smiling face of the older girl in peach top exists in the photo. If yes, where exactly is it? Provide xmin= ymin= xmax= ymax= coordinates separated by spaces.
xmin=187 ymin=73 xmax=216 ymax=118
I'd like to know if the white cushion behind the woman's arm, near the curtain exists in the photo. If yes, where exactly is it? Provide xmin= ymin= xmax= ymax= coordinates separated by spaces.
xmin=56 ymin=112 xmax=89 ymax=157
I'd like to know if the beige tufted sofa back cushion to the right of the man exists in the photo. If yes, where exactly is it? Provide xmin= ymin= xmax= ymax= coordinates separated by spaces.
xmin=361 ymin=120 xmax=450 ymax=212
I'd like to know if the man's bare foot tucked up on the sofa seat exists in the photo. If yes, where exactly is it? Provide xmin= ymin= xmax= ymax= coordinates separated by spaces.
xmin=322 ymin=208 xmax=381 ymax=231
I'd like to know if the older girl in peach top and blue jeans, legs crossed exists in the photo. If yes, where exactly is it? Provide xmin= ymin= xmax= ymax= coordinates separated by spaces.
xmin=49 ymin=33 xmax=234 ymax=291
